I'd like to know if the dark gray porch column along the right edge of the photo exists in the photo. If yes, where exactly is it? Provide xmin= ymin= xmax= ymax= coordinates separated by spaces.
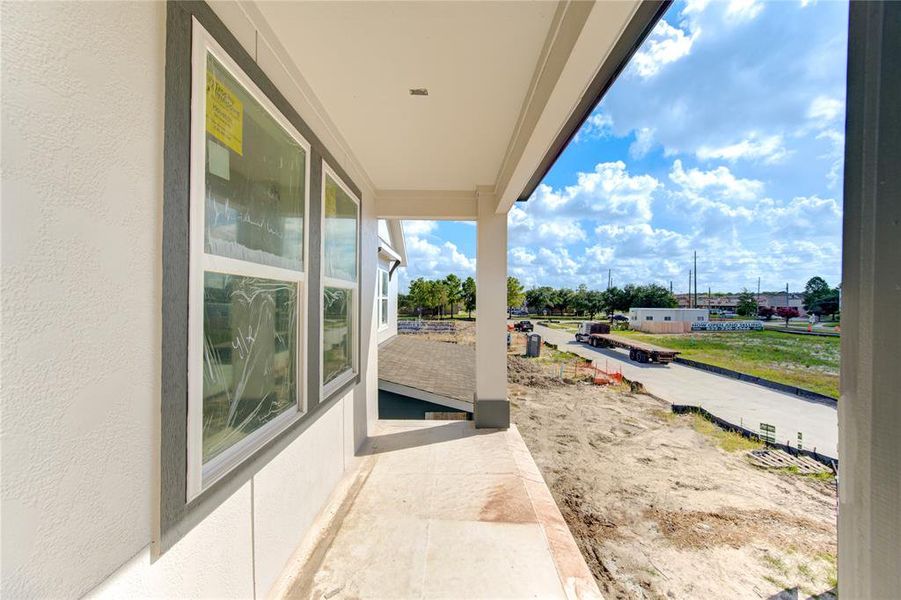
xmin=838 ymin=2 xmax=901 ymax=598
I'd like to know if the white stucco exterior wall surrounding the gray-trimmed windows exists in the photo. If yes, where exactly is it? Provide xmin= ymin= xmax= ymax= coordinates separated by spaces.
xmin=0 ymin=2 xmax=377 ymax=598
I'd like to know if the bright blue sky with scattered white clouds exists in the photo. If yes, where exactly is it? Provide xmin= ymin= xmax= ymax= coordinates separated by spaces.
xmin=401 ymin=0 xmax=848 ymax=292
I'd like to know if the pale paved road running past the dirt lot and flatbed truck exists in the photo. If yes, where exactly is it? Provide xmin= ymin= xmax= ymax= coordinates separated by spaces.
xmin=535 ymin=325 xmax=838 ymax=458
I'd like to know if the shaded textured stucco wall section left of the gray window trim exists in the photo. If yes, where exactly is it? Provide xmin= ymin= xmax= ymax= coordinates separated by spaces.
xmin=0 ymin=2 xmax=165 ymax=598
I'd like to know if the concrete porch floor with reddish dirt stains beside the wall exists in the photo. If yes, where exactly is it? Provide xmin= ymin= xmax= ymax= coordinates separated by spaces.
xmin=270 ymin=421 xmax=601 ymax=599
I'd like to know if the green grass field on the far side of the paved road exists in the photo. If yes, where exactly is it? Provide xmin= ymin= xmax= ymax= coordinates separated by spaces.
xmin=623 ymin=331 xmax=840 ymax=398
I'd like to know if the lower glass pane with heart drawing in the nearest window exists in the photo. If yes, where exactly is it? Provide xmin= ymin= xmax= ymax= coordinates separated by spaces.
xmin=203 ymin=272 xmax=297 ymax=462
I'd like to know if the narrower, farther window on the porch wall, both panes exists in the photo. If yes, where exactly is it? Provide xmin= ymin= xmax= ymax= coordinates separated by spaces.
xmin=320 ymin=163 xmax=360 ymax=399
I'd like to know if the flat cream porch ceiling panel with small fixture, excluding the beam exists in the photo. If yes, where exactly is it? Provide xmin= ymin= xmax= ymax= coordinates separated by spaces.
xmin=256 ymin=2 xmax=557 ymax=190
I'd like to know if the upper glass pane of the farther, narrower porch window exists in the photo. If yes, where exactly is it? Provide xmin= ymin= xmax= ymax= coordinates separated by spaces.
xmin=322 ymin=175 xmax=357 ymax=281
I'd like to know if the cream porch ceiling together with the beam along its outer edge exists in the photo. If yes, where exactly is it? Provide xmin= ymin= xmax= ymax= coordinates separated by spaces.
xmin=254 ymin=1 xmax=638 ymax=211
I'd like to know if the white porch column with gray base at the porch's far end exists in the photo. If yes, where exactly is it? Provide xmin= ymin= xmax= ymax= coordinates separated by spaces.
xmin=474 ymin=189 xmax=510 ymax=428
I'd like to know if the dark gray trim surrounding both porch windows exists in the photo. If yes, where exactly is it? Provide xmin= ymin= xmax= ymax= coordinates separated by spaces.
xmin=162 ymin=2 xmax=363 ymax=556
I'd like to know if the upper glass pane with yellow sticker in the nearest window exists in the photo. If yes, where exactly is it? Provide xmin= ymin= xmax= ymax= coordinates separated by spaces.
xmin=204 ymin=54 xmax=307 ymax=271
